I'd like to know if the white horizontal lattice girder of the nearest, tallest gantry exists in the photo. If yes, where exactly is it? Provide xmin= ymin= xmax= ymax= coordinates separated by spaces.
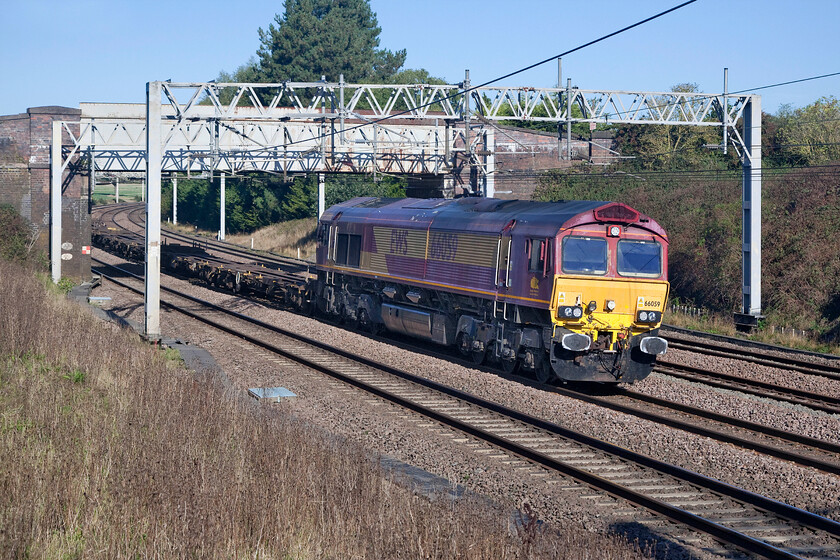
xmin=158 ymin=82 xmax=751 ymax=126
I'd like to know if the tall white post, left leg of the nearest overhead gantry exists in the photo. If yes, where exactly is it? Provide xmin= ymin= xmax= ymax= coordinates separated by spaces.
xmin=141 ymin=82 xmax=163 ymax=341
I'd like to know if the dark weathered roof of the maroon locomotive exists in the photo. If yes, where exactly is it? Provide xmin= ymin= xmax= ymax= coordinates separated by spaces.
xmin=321 ymin=197 xmax=664 ymax=235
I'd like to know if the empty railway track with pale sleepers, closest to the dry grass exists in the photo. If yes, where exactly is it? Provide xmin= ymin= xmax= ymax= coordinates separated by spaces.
xmin=92 ymin=258 xmax=840 ymax=558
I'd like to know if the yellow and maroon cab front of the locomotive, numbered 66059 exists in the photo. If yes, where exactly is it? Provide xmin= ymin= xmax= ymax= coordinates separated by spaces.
xmin=550 ymin=203 xmax=669 ymax=383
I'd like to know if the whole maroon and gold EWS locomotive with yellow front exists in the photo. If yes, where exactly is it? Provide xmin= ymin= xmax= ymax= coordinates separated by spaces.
xmin=311 ymin=197 xmax=669 ymax=383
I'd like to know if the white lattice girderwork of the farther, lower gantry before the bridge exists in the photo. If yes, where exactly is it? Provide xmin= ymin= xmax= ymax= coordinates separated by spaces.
xmin=71 ymin=119 xmax=464 ymax=174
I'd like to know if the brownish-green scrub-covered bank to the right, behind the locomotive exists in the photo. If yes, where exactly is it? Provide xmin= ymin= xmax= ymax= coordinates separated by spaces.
xmin=534 ymin=161 xmax=840 ymax=339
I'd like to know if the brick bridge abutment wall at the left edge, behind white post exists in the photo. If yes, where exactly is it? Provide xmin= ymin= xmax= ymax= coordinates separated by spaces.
xmin=0 ymin=107 xmax=90 ymax=281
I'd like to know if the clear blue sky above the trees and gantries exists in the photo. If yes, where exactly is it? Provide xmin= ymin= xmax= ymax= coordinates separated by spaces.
xmin=0 ymin=0 xmax=840 ymax=115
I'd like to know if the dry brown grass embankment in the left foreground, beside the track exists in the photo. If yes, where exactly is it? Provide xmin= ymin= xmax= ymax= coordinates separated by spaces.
xmin=0 ymin=261 xmax=640 ymax=559
